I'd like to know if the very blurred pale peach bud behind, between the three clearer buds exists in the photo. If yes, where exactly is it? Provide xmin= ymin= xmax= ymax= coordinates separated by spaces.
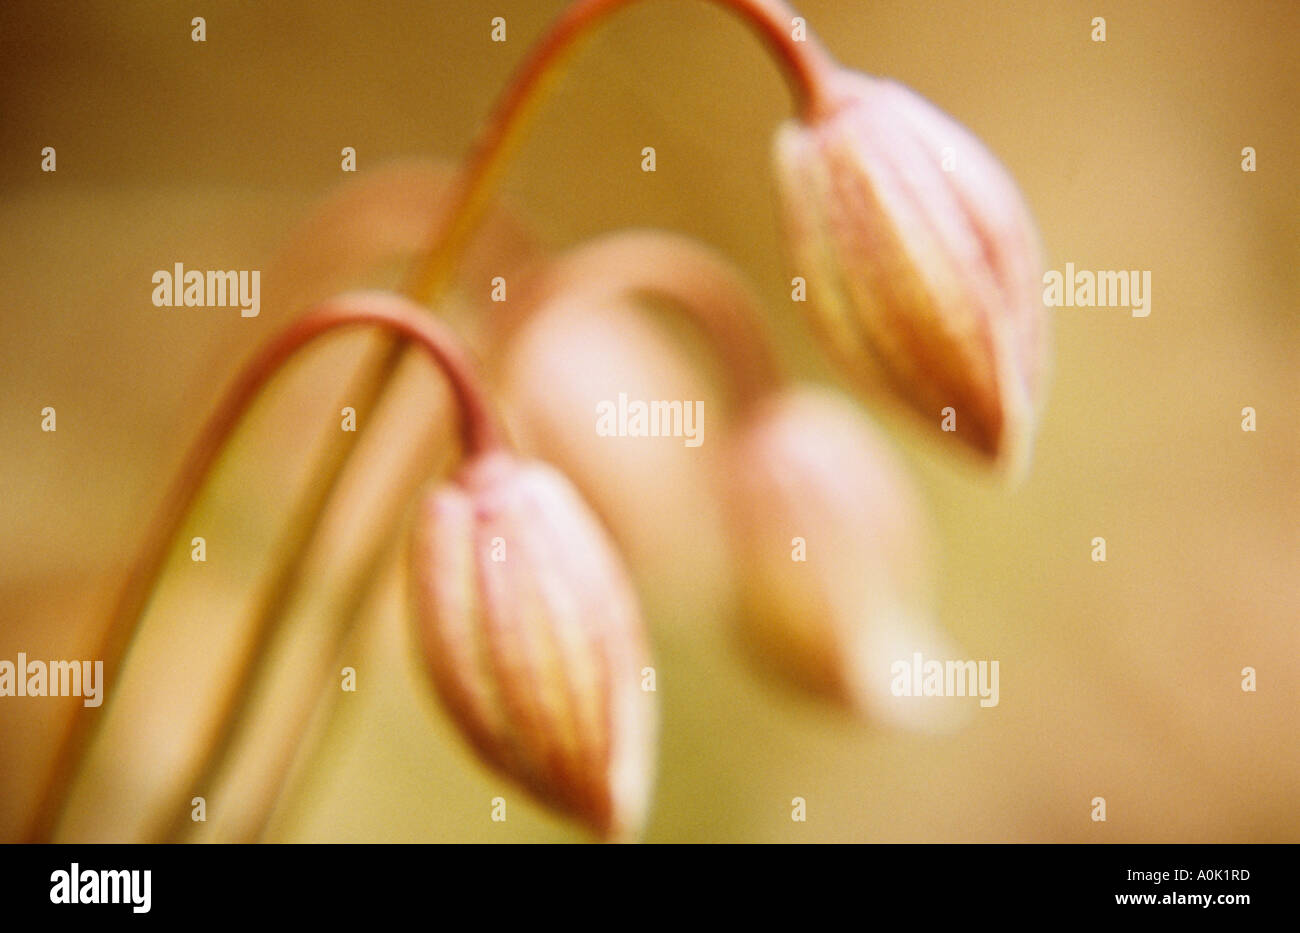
xmin=502 ymin=288 xmax=727 ymax=602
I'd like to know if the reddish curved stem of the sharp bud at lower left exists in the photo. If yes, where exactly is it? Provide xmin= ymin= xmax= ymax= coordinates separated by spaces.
xmin=26 ymin=292 xmax=503 ymax=841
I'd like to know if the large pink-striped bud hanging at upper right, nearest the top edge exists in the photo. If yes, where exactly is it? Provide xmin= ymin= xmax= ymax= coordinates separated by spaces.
xmin=776 ymin=70 xmax=1047 ymax=473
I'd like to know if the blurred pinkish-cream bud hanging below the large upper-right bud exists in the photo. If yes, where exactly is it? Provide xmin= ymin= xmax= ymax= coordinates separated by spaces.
xmin=728 ymin=387 xmax=972 ymax=729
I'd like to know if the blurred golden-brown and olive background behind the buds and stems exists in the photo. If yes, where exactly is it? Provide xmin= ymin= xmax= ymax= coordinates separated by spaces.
xmin=0 ymin=0 xmax=1300 ymax=842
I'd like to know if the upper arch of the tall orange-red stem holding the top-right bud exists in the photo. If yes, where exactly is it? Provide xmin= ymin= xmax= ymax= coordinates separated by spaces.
xmin=406 ymin=0 xmax=833 ymax=300
